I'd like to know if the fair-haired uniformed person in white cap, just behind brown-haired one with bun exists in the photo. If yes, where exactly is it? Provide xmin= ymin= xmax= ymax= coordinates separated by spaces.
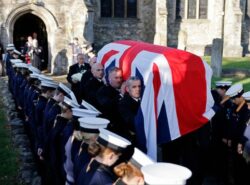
xmin=64 ymin=116 xmax=109 ymax=184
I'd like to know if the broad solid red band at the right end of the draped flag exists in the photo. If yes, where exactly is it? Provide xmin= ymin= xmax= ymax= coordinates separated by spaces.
xmin=164 ymin=50 xmax=208 ymax=135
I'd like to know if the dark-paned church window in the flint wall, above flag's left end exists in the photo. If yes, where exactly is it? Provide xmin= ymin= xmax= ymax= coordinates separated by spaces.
xmin=101 ymin=0 xmax=137 ymax=18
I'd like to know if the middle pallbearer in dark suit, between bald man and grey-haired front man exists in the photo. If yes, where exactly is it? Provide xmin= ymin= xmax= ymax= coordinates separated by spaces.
xmin=96 ymin=67 xmax=123 ymax=134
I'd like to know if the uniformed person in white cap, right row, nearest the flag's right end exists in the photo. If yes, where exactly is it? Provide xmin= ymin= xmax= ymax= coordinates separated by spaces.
xmin=210 ymin=81 xmax=234 ymax=183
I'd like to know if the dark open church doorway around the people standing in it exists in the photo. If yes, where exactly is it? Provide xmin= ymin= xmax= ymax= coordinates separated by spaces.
xmin=13 ymin=13 xmax=48 ymax=70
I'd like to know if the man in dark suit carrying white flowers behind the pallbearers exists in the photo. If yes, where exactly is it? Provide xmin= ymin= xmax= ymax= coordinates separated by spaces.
xmin=67 ymin=54 xmax=90 ymax=103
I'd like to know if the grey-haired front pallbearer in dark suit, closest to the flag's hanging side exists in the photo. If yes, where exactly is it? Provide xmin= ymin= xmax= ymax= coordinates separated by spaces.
xmin=119 ymin=76 xmax=141 ymax=144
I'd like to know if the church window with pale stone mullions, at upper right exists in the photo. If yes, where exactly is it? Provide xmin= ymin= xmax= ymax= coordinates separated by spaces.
xmin=176 ymin=0 xmax=208 ymax=19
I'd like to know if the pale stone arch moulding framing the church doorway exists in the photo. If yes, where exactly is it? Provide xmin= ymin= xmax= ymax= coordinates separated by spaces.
xmin=4 ymin=3 xmax=60 ymax=70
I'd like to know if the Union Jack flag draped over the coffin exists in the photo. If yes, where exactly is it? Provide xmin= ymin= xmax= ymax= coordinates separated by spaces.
xmin=97 ymin=40 xmax=214 ymax=159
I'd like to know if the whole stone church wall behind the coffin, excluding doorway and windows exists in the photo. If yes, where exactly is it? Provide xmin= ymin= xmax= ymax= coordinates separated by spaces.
xmin=0 ymin=0 xmax=250 ymax=74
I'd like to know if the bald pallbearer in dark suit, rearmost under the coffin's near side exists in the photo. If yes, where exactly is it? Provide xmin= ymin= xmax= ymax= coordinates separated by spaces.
xmin=84 ymin=63 xmax=104 ymax=109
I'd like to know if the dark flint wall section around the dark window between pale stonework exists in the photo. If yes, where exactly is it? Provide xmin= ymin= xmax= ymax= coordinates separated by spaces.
xmin=94 ymin=0 xmax=155 ymax=48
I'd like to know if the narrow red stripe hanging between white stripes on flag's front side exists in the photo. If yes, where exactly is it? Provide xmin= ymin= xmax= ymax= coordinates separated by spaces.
xmin=153 ymin=64 xmax=161 ymax=128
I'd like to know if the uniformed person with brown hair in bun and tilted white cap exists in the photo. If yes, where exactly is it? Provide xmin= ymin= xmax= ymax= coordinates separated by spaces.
xmin=76 ymin=129 xmax=131 ymax=185
